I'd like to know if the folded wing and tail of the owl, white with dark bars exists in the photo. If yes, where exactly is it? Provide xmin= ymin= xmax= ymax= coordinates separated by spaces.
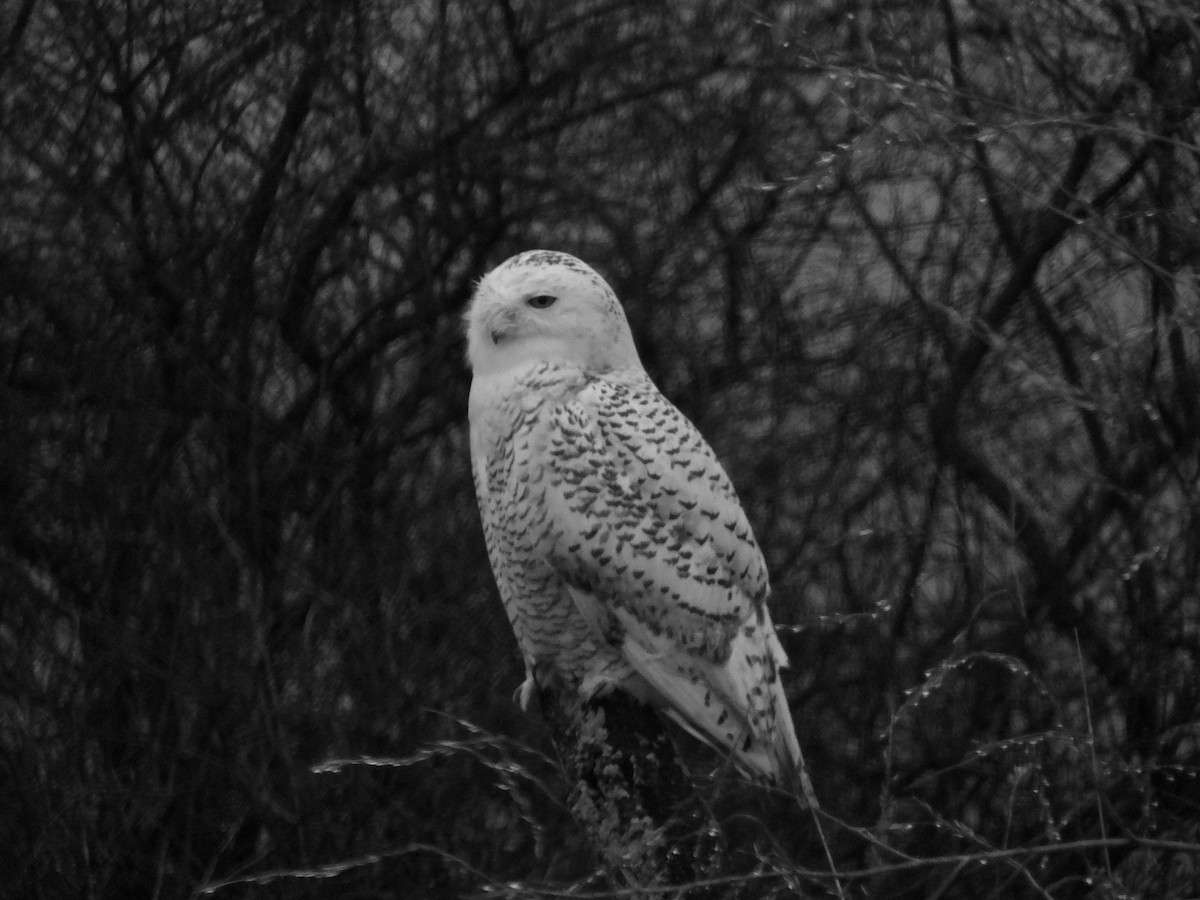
xmin=545 ymin=376 xmax=800 ymax=780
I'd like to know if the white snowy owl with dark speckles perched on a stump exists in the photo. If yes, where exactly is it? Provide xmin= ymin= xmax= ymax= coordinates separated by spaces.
xmin=467 ymin=251 xmax=800 ymax=781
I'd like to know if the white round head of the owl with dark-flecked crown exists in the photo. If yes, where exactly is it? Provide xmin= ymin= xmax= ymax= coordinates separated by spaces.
xmin=467 ymin=250 xmax=640 ymax=376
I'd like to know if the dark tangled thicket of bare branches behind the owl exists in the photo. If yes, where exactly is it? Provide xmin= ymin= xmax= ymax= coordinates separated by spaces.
xmin=0 ymin=0 xmax=1200 ymax=898
